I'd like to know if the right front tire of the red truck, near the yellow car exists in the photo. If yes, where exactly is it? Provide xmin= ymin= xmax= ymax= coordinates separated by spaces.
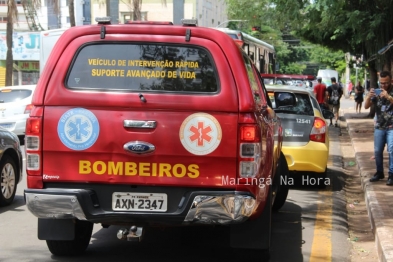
xmin=272 ymin=153 xmax=289 ymax=211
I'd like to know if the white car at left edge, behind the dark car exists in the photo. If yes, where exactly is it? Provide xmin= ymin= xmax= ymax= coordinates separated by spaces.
xmin=0 ymin=85 xmax=36 ymax=136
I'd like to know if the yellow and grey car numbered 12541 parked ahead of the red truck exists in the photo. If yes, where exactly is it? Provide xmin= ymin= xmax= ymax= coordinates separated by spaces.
xmin=266 ymin=85 xmax=333 ymax=187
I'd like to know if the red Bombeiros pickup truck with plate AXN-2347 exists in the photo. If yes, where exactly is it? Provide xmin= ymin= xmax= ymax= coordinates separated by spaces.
xmin=24 ymin=16 xmax=295 ymax=255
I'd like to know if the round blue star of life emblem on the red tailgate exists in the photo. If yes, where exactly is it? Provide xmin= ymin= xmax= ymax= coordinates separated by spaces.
xmin=57 ymin=108 xmax=100 ymax=150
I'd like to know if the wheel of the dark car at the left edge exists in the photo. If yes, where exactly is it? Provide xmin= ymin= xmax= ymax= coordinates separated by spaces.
xmin=0 ymin=156 xmax=19 ymax=206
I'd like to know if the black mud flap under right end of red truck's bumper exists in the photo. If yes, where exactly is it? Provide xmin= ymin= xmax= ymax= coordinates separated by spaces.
xmin=230 ymin=187 xmax=272 ymax=252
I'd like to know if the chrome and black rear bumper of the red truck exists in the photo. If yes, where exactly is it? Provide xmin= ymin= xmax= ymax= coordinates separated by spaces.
xmin=25 ymin=189 xmax=256 ymax=225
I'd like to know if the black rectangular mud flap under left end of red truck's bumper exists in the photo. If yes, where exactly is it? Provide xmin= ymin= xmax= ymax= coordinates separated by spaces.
xmin=38 ymin=218 xmax=75 ymax=240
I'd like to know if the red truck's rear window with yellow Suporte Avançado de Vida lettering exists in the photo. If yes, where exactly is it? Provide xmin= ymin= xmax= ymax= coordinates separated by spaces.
xmin=66 ymin=43 xmax=219 ymax=93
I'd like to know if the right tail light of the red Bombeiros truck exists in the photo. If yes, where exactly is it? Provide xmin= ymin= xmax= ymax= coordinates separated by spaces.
xmin=239 ymin=124 xmax=261 ymax=178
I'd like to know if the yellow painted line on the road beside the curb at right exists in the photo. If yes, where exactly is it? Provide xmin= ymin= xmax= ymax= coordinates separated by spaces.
xmin=310 ymin=190 xmax=333 ymax=262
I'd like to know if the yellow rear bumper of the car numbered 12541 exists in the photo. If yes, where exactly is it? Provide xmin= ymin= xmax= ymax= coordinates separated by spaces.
xmin=282 ymin=142 xmax=329 ymax=173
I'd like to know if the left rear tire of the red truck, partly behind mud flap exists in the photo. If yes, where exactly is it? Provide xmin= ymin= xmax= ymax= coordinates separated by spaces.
xmin=46 ymin=220 xmax=93 ymax=256
